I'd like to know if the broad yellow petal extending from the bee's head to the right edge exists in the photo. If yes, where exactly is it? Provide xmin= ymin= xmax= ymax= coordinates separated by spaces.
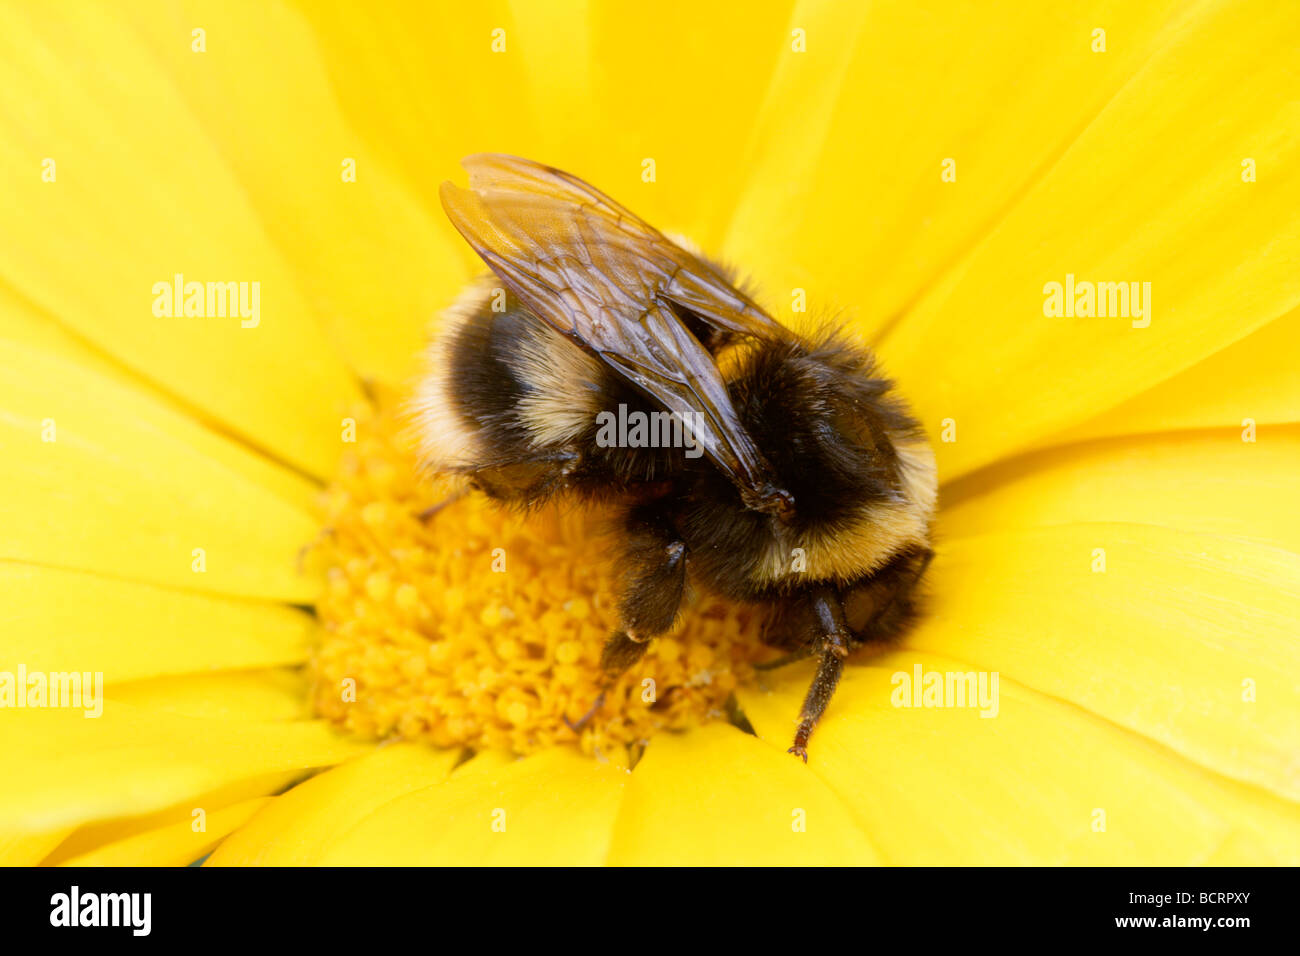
xmin=909 ymin=523 xmax=1300 ymax=800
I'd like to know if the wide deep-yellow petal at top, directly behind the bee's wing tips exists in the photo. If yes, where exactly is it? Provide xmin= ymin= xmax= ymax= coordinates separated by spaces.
xmin=300 ymin=0 xmax=790 ymax=252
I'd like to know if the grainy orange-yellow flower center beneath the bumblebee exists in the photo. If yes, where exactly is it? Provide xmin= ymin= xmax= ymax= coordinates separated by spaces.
xmin=311 ymin=399 xmax=771 ymax=753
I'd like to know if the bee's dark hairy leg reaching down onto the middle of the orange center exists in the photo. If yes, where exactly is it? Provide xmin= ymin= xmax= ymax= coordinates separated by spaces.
xmin=564 ymin=510 xmax=686 ymax=732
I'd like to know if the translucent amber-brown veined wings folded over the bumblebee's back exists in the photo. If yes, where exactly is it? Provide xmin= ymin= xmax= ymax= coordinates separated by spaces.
xmin=441 ymin=153 xmax=788 ymax=512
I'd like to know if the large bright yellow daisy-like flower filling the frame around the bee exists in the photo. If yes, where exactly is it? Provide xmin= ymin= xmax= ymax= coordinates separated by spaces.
xmin=0 ymin=0 xmax=1300 ymax=865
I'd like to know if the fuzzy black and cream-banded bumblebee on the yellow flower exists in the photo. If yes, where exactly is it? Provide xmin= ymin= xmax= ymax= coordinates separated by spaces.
xmin=413 ymin=155 xmax=937 ymax=761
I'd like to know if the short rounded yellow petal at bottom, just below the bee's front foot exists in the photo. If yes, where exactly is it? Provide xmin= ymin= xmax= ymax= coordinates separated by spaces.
xmin=608 ymin=723 xmax=878 ymax=866
